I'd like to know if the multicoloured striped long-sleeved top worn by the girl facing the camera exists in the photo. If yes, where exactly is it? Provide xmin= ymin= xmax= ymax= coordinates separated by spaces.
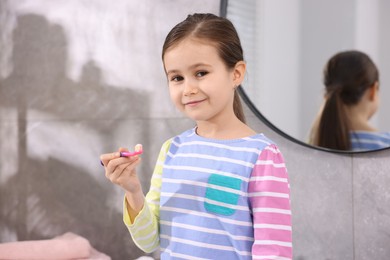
xmin=124 ymin=129 xmax=292 ymax=259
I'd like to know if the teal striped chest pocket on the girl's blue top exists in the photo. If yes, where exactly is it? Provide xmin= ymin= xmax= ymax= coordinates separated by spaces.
xmin=204 ymin=174 xmax=242 ymax=216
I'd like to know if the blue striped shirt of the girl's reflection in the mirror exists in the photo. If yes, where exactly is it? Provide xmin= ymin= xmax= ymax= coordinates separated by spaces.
xmin=350 ymin=131 xmax=390 ymax=151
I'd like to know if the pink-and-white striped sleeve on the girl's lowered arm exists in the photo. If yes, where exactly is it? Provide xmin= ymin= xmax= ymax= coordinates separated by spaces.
xmin=248 ymin=145 xmax=292 ymax=259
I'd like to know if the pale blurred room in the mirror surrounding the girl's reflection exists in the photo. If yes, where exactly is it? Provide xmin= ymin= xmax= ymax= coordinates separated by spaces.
xmin=226 ymin=0 xmax=390 ymax=151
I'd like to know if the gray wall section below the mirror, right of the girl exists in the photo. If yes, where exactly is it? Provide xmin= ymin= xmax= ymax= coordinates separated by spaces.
xmin=248 ymin=111 xmax=390 ymax=260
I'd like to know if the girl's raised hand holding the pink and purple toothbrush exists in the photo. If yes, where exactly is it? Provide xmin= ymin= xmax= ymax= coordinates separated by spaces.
xmin=100 ymin=145 xmax=142 ymax=193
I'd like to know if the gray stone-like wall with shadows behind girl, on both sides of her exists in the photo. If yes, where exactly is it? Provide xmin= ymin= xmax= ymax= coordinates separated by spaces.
xmin=0 ymin=0 xmax=390 ymax=260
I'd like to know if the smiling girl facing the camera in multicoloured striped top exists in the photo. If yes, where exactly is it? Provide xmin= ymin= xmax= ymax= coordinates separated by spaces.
xmin=101 ymin=14 xmax=292 ymax=259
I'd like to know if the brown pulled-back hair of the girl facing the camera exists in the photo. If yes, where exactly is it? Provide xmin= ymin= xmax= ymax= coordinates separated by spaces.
xmin=162 ymin=13 xmax=245 ymax=123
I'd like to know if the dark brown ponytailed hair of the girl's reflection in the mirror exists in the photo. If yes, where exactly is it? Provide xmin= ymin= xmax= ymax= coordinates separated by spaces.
xmin=315 ymin=51 xmax=379 ymax=150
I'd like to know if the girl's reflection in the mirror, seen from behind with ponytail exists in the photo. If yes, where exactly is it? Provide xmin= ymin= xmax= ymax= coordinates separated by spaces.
xmin=310 ymin=50 xmax=390 ymax=151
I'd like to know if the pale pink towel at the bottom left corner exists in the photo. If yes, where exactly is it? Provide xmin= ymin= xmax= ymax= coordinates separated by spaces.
xmin=0 ymin=232 xmax=111 ymax=260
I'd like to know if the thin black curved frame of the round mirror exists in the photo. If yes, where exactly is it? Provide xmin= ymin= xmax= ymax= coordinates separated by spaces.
xmin=219 ymin=0 xmax=390 ymax=154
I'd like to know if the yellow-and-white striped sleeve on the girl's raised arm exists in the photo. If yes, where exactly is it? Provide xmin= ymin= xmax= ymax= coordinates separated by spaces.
xmin=123 ymin=140 xmax=171 ymax=253
